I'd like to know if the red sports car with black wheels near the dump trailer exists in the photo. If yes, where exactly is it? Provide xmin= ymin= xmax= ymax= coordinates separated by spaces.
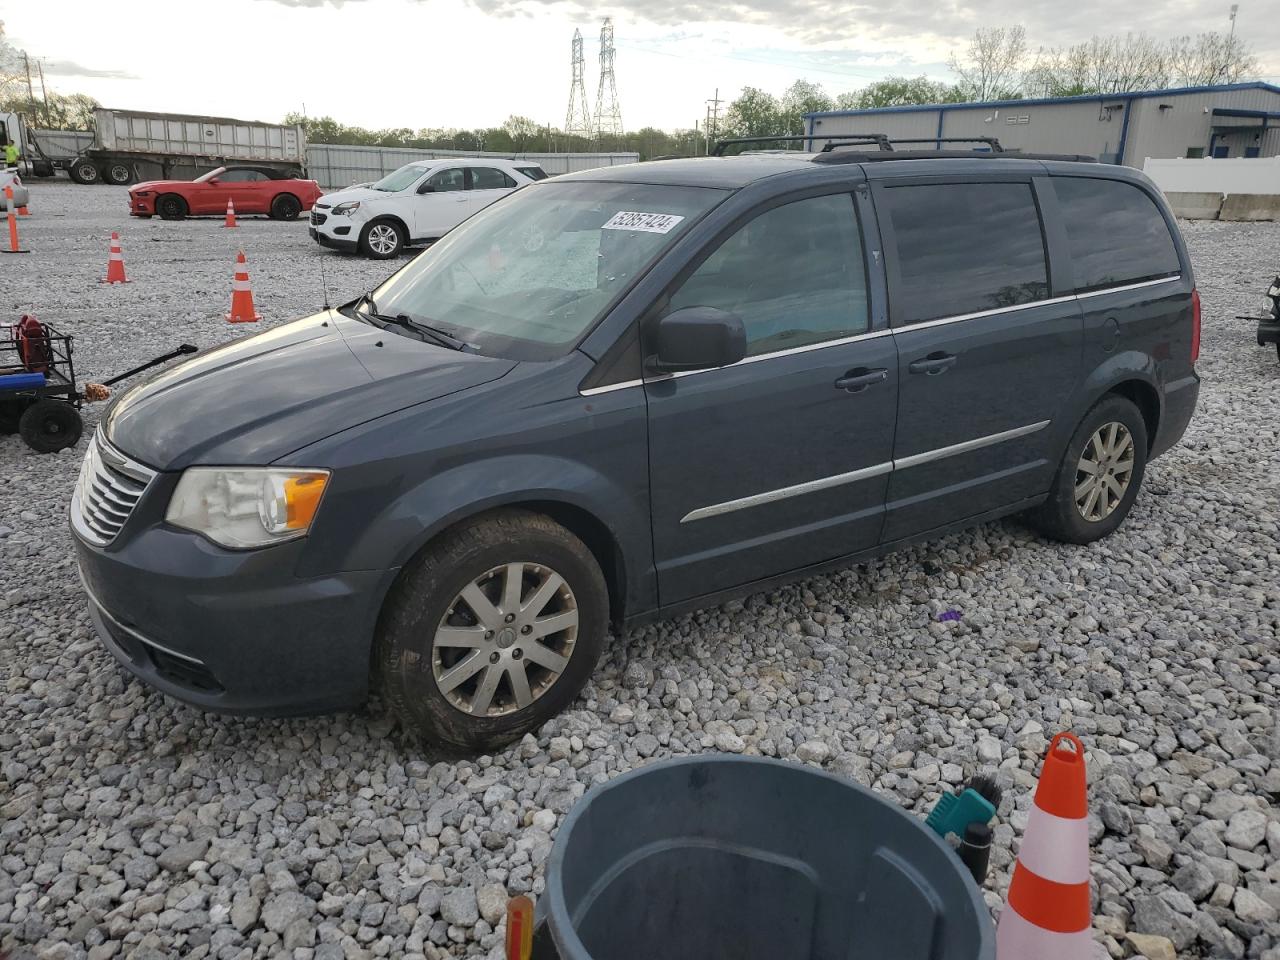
xmin=129 ymin=166 xmax=321 ymax=220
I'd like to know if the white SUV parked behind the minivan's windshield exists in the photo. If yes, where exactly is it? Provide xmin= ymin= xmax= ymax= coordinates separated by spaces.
xmin=311 ymin=157 xmax=547 ymax=260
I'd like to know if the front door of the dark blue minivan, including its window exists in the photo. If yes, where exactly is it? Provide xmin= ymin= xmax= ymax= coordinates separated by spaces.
xmin=645 ymin=192 xmax=897 ymax=604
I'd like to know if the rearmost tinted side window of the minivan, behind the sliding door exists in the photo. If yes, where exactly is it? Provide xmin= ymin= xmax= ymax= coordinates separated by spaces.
xmin=1053 ymin=177 xmax=1181 ymax=291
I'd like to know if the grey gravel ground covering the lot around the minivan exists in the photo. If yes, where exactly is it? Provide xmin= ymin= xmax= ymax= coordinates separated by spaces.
xmin=0 ymin=184 xmax=1280 ymax=960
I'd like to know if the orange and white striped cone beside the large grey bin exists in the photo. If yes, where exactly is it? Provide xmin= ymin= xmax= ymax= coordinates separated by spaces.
xmin=996 ymin=733 xmax=1093 ymax=960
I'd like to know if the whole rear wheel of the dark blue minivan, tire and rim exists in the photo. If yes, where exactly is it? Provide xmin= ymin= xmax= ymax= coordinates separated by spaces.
xmin=1028 ymin=394 xmax=1148 ymax=544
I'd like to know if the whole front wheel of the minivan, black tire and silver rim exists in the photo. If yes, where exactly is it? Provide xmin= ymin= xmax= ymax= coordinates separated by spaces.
xmin=376 ymin=509 xmax=609 ymax=753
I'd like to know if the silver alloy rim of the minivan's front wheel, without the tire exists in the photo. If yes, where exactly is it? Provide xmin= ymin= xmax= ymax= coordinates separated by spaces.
xmin=431 ymin=563 xmax=577 ymax=717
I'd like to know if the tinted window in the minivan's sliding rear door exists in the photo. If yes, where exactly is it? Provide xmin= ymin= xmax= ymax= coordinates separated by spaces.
xmin=877 ymin=183 xmax=1048 ymax=324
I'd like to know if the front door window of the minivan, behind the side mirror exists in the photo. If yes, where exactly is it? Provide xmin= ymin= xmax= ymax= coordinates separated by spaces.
xmin=669 ymin=193 xmax=868 ymax=357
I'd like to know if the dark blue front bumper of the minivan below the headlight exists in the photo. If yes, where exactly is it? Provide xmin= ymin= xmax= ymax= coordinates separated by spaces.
xmin=73 ymin=519 xmax=394 ymax=716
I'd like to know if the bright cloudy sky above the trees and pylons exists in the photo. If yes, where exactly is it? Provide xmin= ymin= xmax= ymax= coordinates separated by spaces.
xmin=0 ymin=0 xmax=1280 ymax=129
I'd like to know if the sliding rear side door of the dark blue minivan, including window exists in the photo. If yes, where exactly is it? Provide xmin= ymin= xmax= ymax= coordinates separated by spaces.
xmin=873 ymin=177 xmax=1083 ymax=541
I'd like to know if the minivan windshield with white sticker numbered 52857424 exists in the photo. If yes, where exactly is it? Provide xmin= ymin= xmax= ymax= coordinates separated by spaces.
xmin=372 ymin=180 xmax=728 ymax=360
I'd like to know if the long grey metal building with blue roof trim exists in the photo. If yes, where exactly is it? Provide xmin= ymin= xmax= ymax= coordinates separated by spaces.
xmin=805 ymin=82 xmax=1280 ymax=168
